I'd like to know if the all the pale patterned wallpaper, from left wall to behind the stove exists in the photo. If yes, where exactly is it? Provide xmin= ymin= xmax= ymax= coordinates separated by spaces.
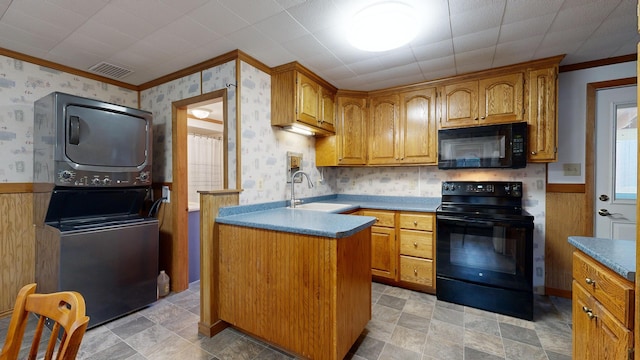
xmin=0 ymin=52 xmax=546 ymax=286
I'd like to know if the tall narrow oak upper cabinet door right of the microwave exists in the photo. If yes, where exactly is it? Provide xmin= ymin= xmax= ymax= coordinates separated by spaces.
xmin=527 ymin=67 xmax=558 ymax=162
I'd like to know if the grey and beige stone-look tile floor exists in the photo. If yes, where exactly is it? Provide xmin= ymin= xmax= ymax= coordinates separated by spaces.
xmin=0 ymin=282 xmax=571 ymax=360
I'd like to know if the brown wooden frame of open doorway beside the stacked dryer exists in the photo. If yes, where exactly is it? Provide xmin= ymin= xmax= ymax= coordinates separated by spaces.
xmin=169 ymin=88 xmax=229 ymax=291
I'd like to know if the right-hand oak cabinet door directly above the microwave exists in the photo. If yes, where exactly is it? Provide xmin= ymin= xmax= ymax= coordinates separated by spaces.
xmin=478 ymin=73 xmax=524 ymax=124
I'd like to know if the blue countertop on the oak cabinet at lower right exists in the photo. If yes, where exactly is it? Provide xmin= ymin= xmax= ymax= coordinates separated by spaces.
xmin=569 ymin=236 xmax=636 ymax=281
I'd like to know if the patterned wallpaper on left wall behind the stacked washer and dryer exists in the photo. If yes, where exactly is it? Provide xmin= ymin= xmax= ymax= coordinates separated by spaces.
xmin=0 ymin=56 xmax=138 ymax=183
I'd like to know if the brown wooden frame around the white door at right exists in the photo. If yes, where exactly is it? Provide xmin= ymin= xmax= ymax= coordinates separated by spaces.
xmin=584 ymin=77 xmax=637 ymax=236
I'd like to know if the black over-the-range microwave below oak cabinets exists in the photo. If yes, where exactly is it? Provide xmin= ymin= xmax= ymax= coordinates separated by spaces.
xmin=438 ymin=122 xmax=527 ymax=169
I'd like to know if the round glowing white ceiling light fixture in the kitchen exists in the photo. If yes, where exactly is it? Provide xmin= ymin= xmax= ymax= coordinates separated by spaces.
xmin=347 ymin=1 xmax=419 ymax=51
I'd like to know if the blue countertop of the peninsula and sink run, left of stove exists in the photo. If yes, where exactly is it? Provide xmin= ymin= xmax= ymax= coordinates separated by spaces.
xmin=216 ymin=195 xmax=440 ymax=238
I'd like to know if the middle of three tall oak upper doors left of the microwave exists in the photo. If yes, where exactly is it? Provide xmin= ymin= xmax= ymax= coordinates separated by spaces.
xmin=369 ymin=95 xmax=400 ymax=164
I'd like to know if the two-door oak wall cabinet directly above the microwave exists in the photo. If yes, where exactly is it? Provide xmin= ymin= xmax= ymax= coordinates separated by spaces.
xmin=439 ymin=72 xmax=524 ymax=129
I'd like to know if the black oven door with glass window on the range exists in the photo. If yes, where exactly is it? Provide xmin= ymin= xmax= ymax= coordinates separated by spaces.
xmin=436 ymin=214 xmax=533 ymax=291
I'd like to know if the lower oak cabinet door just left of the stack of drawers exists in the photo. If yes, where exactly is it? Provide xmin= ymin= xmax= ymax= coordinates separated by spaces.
xmin=371 ymin=226 xmax=397 ymax=280
